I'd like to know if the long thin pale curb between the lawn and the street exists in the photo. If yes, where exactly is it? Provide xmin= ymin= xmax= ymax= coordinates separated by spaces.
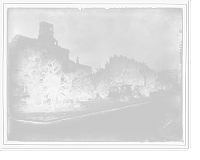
xmin=9 ymin=97 xmax=169 ymax=124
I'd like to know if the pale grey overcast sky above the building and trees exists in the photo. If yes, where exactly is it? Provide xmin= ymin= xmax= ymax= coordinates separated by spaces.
xmin=8 ymin=8 xmax=182 ymax=71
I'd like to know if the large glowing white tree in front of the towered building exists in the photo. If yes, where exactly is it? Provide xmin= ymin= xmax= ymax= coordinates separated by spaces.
xmin=10 ymin=46 xmax=63 ymax=109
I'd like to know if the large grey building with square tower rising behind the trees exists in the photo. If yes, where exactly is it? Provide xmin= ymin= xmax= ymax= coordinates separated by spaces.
xmin=8 ymin=21 xmax=91 ymax=73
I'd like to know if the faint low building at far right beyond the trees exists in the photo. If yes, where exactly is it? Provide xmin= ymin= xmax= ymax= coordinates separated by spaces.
xmin=155 ymin=69 xmax=182 ymax=90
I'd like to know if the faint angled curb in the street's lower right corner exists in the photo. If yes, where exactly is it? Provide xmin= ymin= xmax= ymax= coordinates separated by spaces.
xmin=158 ymin=116 xmax=181 ymax=137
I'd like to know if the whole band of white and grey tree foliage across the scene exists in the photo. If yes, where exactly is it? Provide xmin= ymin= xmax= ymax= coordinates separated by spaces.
xmin=9 ymin=46 xmax=158 ymax=109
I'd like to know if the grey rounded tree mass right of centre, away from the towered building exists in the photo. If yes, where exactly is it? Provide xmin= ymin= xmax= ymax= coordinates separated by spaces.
xmin=101 ymin=55 xmax=156 ymax=90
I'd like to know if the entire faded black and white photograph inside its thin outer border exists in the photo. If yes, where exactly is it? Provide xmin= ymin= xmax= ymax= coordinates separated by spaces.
xmin=4 ymin=1 xmax=186 ymax=149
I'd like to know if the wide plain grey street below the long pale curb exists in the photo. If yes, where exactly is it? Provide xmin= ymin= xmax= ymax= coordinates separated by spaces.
xmin=8 ymin=94 xmax=181 ymax=141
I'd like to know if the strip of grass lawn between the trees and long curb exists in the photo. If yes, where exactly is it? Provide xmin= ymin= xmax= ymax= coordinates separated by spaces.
xmin=8 ymin=96 xmax=162 ymax=121
